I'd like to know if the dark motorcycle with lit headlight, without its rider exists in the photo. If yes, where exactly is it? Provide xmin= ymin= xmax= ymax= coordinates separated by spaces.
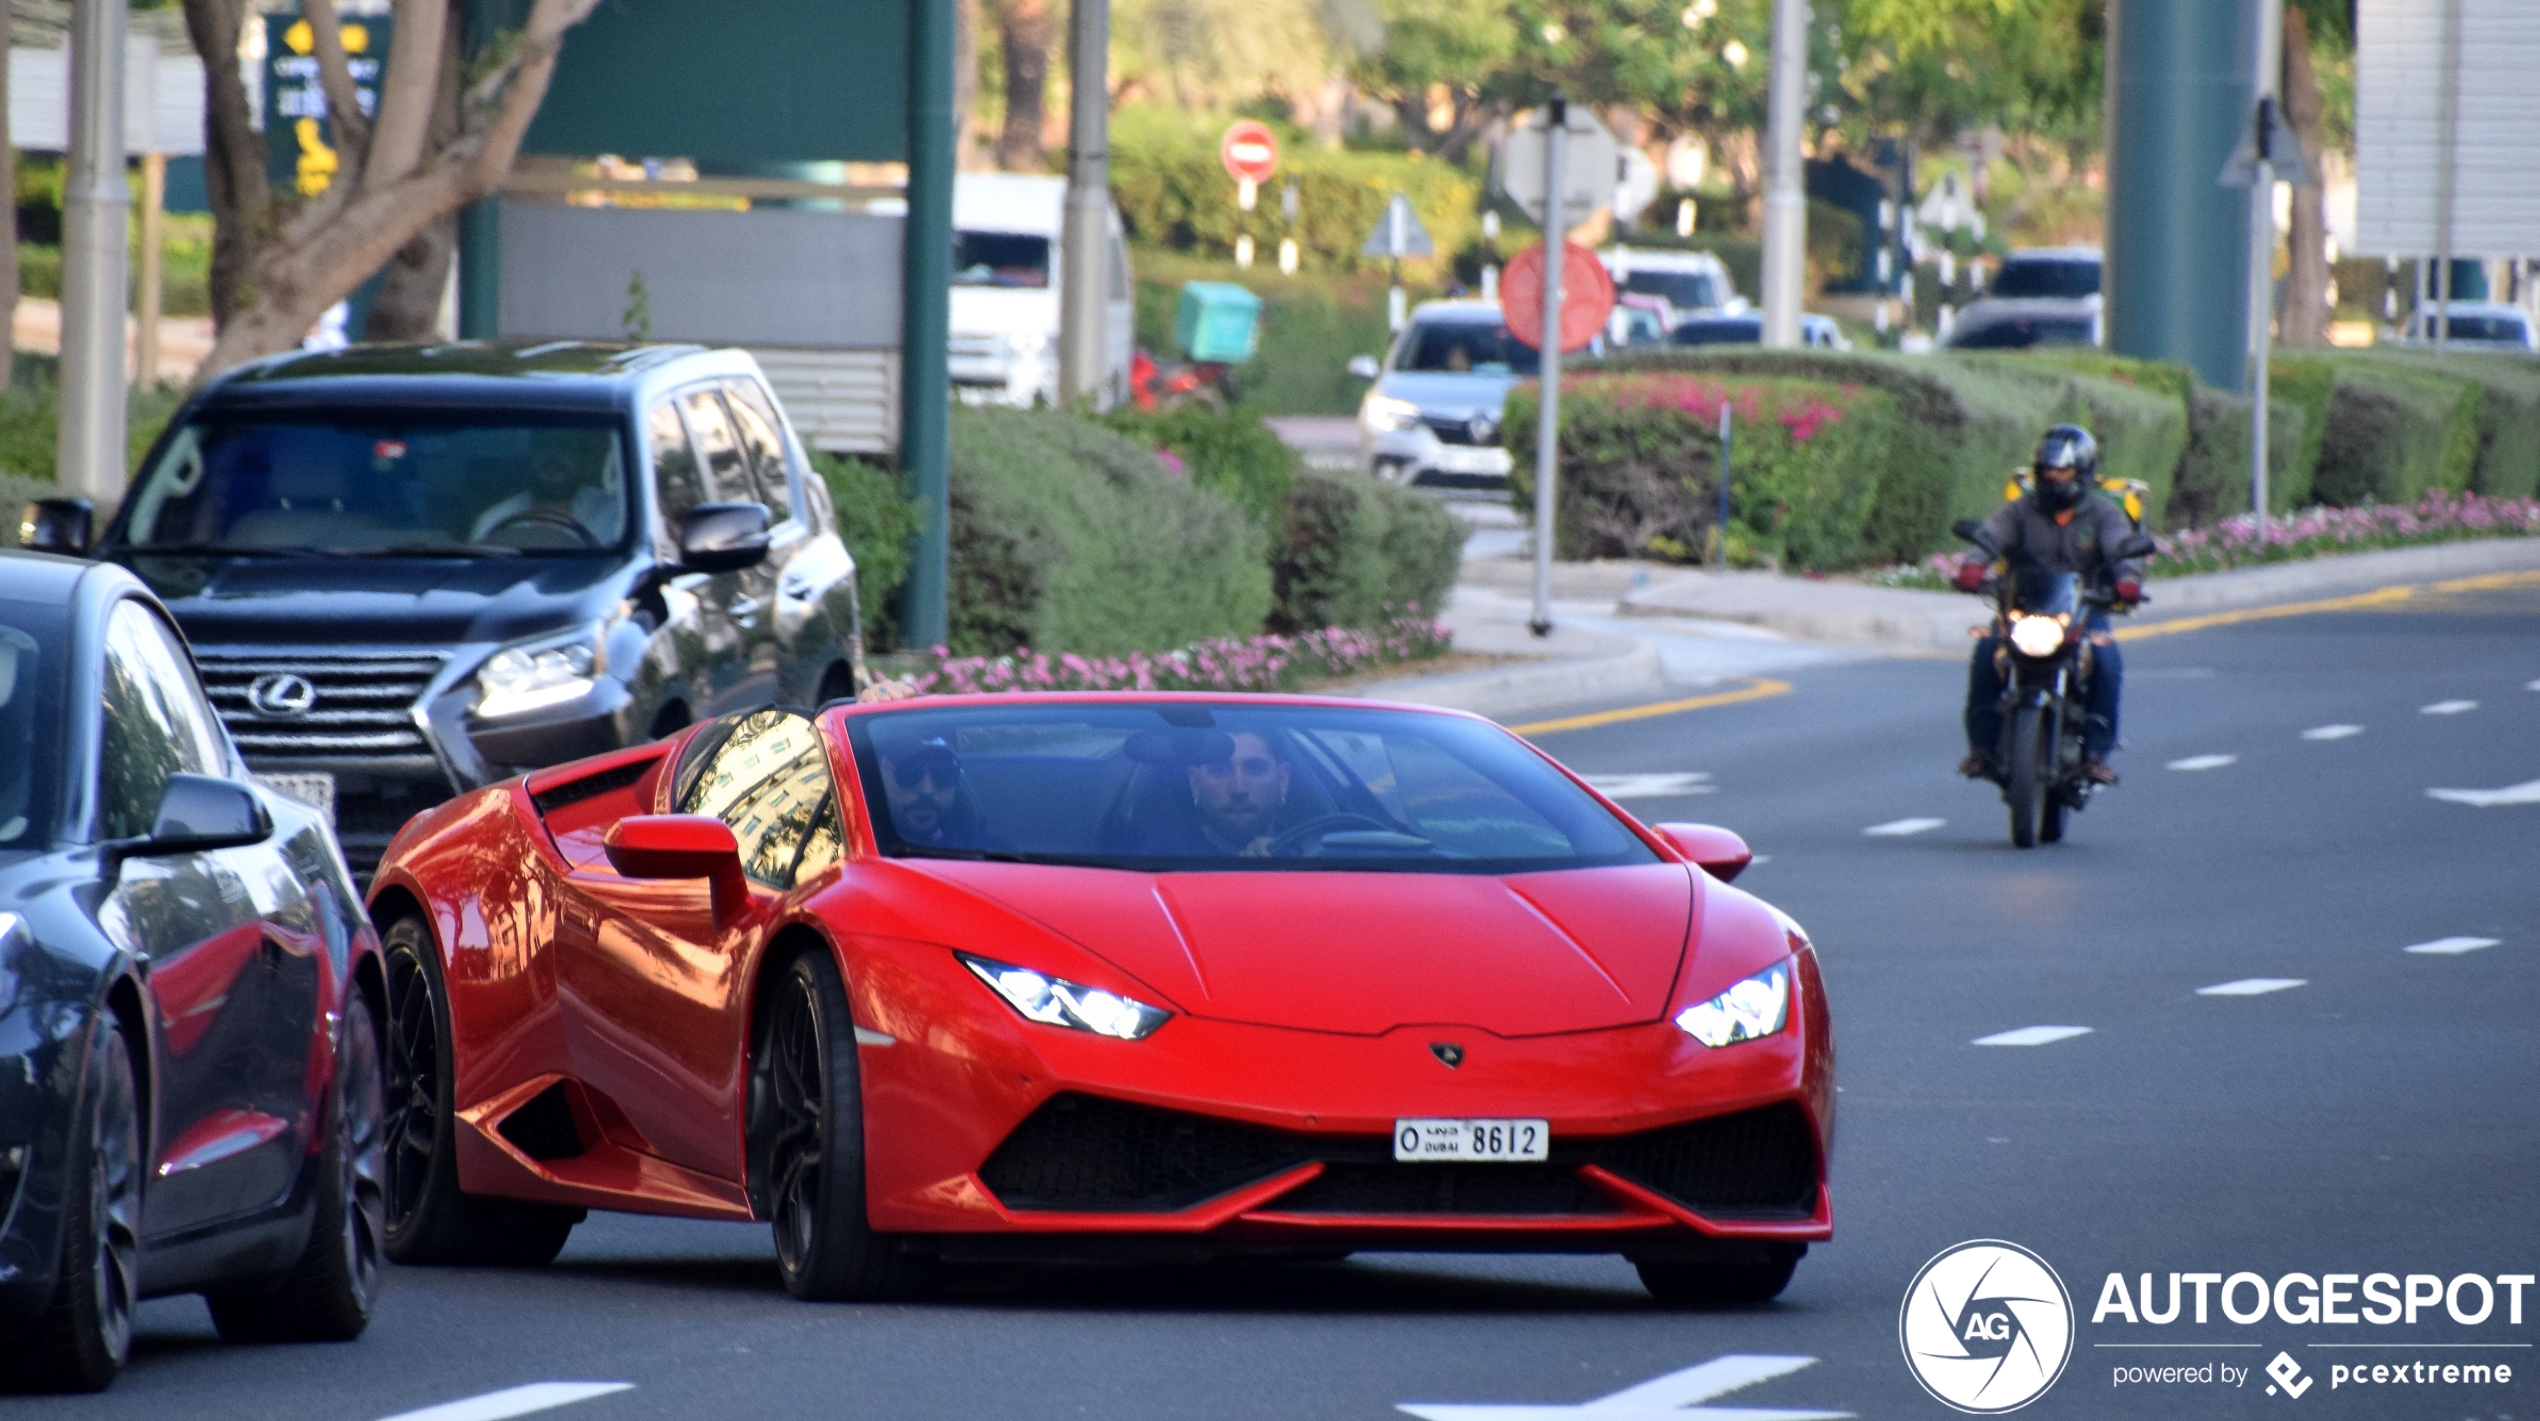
xmin=1951 ymin=519 xmax=2154 ymax=849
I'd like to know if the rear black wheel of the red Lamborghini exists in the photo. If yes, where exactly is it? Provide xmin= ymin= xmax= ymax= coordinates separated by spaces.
xmin=381 ymin=918 xmax=582 ymax=1268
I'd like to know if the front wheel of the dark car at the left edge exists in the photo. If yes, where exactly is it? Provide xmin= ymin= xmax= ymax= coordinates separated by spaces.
xmin=0 ymin=1014 xmax=142 ymax=1390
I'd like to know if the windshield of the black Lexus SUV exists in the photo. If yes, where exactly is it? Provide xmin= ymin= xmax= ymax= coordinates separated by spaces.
xmin=122 ymin=409 xmax=632 ymax=557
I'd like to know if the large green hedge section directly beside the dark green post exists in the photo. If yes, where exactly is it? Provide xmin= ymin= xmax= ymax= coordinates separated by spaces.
xmin=950 ymin=407 xmax=1270 ymax=656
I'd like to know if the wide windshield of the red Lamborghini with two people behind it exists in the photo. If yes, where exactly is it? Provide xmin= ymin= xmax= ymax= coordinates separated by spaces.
xmin=848 ymin=702 xmax=1656 ymax=874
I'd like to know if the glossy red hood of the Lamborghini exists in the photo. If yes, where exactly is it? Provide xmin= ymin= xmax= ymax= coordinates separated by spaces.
xmin=912 ymin=859 xmax=1694 ymax=1037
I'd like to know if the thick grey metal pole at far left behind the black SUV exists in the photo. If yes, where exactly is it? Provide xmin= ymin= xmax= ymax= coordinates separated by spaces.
xmin=53 ymin=0 xmax=132 ymax=506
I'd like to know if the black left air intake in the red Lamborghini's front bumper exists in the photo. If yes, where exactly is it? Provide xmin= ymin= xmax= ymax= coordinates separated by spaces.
xmin=978 ymin=1096 xmax=1311 ymax=1213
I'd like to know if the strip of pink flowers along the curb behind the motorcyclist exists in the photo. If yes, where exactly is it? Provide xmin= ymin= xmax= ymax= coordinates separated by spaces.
xmin=1869 ymin=488 xmax=2540 ymax=590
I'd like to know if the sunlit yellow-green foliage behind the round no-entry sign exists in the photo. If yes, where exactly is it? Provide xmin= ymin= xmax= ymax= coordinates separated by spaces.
xmin=1110 ymin=107 xmax=1481 ymax=272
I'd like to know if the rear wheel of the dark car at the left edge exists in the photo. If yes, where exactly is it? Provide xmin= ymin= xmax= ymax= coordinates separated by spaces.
xmin=203 ymin=991 xmax=389 ymax=1342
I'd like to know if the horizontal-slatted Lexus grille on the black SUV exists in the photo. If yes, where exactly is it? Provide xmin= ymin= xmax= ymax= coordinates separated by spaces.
xmin=196 ymin=648 xmax=447 ymax=760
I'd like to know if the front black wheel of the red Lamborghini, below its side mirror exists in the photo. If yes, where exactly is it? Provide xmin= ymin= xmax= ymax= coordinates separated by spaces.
xmin=749 ymin=951 xmax=932 ymax=1302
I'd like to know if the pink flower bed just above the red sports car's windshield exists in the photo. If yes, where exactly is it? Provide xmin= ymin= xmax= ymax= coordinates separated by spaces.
xmin=907 ymin=608 xmax=1453 ymax=697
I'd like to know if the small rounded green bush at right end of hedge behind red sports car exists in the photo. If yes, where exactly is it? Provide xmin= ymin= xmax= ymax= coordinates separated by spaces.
xmin=1270 ymin=470 xmax=1463 ymax=633
